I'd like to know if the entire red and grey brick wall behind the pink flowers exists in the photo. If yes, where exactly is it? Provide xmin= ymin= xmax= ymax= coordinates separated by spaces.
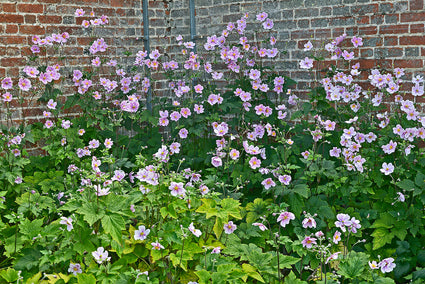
xmin=0 ymin=0 xmax=425 ymax=126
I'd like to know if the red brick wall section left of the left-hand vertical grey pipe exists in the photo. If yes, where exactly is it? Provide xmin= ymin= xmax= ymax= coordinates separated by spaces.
xmin=0 ymin=0 xmax=150 ymax=125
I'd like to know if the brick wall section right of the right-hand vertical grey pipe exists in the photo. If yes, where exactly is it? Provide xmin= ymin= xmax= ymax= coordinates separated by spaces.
xmin=182 ymin=0 xmax=425 ymax=97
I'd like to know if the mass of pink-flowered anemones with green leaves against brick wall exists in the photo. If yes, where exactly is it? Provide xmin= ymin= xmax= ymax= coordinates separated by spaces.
xmin=0 ymin=9 xmax=425 ymax=283
